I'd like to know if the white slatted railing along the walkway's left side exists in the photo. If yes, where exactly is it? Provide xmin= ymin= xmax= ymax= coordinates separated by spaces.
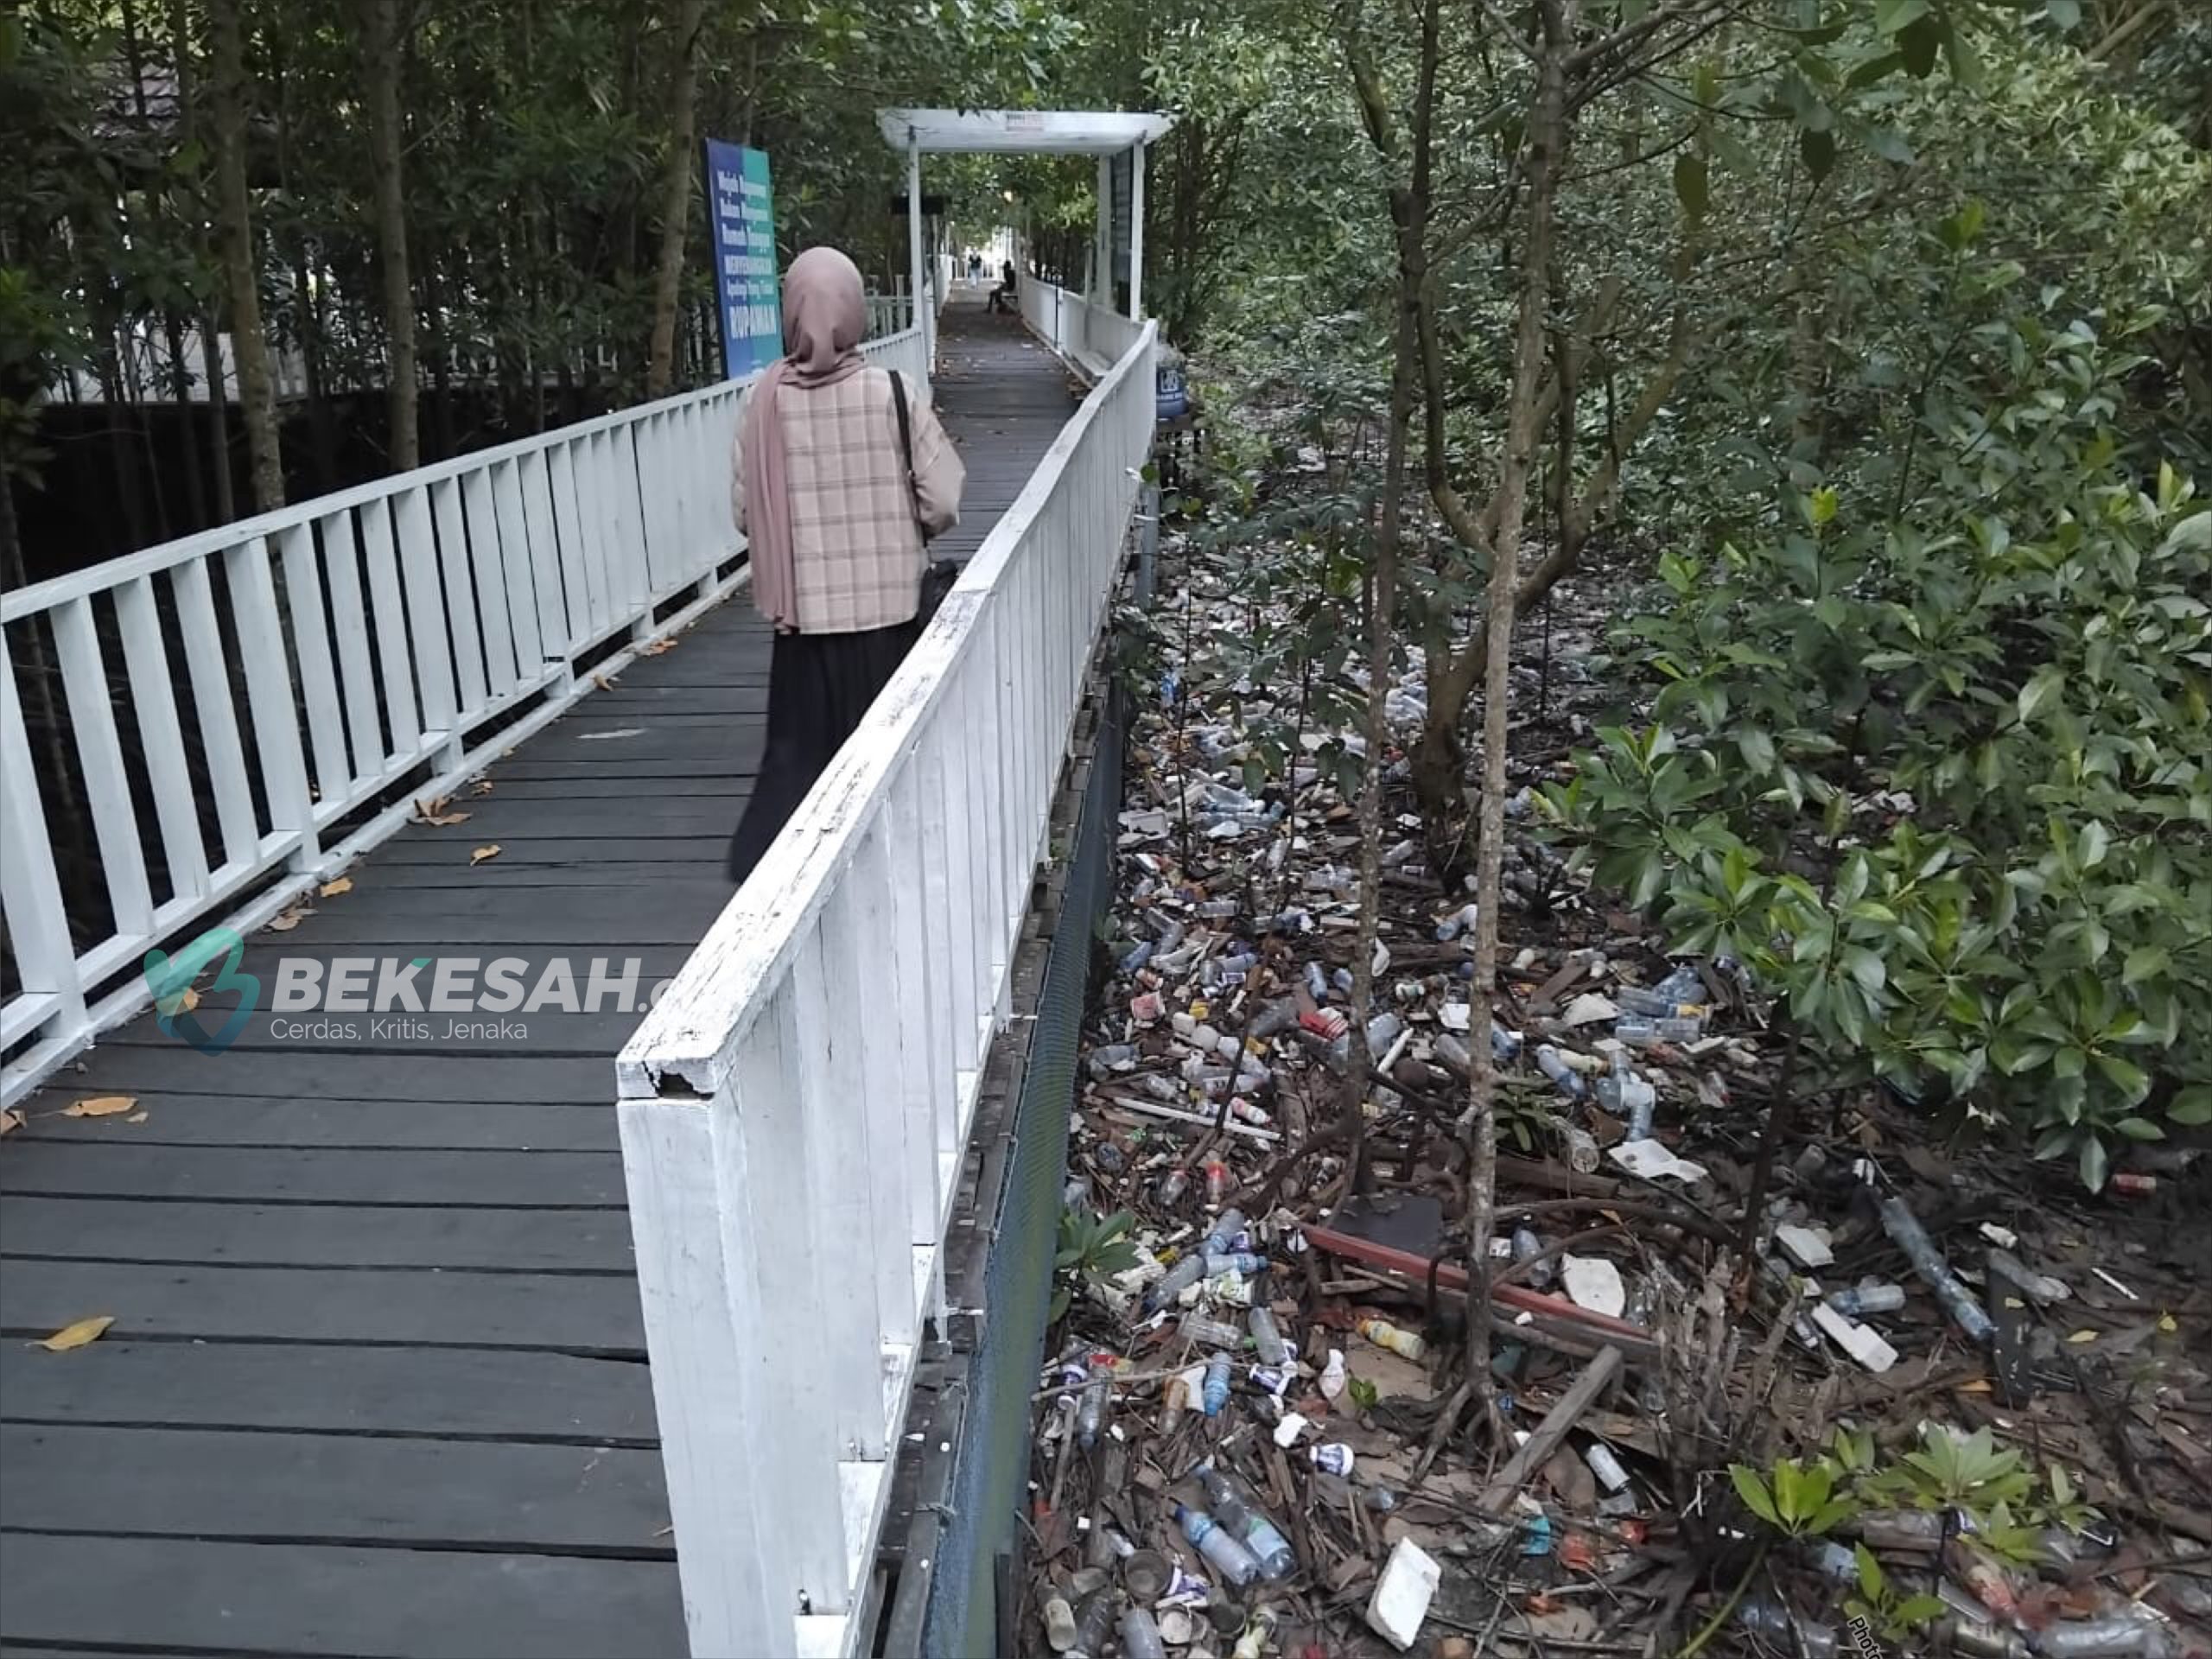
xmin=0 ymin=329 xmax=925 ymax=1103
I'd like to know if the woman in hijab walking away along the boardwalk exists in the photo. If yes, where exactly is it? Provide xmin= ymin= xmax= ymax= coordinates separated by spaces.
xmin=730 ymin=248 xmax=967 ymax=882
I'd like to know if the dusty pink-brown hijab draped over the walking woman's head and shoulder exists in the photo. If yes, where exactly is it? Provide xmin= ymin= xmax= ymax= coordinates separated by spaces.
xmin=743 ymin=248 xmax=868 ymax=628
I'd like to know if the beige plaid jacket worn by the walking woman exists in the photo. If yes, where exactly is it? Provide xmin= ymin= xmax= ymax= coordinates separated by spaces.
xmin=730 ymin=367 xmax=967 ymax=632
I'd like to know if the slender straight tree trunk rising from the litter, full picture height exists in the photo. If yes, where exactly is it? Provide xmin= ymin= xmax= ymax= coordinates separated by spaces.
xmin=1466 ymin=0 xmax=1575 ymax=1370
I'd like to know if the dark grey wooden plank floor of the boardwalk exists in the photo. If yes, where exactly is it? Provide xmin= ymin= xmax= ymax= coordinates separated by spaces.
xmin=0 ymin=296 xmax=1075 ymax=1659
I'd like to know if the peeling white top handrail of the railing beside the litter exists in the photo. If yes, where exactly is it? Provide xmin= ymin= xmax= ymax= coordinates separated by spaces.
xmin=617 ymin=323 xmax=1157 ymax=1095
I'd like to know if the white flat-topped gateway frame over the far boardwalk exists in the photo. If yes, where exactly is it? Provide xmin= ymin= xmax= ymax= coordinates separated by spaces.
xmin=876 ymin=108 xmax=1174 ymax=356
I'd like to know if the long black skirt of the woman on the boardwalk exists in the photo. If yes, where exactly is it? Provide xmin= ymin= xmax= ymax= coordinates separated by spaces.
xmin=730 ymin=621 xmax=923 ymax=882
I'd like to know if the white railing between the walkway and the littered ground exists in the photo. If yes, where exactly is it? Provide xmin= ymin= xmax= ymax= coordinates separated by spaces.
xmin=617 ymin=327 xmax=1154 ymax=1656
